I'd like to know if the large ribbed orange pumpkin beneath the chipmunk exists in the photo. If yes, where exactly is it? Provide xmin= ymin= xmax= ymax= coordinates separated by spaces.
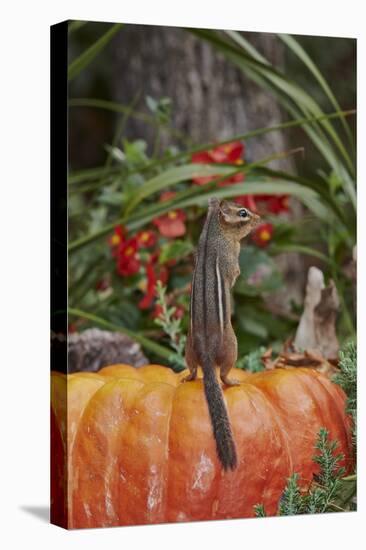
xmin=51 ymin=365 xmax=352 ymax=528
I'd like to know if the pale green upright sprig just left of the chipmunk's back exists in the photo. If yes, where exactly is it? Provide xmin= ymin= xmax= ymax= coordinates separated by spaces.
xmin=155 ymin=281 xmax=186 ymax=370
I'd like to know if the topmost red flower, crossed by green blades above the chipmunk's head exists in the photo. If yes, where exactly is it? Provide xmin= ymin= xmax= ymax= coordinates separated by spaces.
xmin=191 ymin=141 xmax=244 ymax=187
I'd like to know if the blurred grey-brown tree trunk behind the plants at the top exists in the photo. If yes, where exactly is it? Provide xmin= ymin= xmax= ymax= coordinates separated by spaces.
xmin=112 ymin=25 xmax=291 ymax=169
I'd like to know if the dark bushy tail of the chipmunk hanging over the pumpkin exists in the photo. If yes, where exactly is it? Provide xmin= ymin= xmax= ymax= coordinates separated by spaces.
xmin=202 ymin=359 xmax=238 ymax=470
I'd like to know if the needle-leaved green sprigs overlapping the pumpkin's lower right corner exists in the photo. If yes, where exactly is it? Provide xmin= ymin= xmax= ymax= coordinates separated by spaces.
xmin=254 ymin=428 xmax=354 ymax=517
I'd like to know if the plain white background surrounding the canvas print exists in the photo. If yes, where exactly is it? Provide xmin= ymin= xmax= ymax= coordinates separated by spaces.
xmin=0 ymin=0 xmax=366 ymax=550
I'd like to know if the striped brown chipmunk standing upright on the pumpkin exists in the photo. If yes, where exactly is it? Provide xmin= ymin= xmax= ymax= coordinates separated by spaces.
xmin=184 ymin=198 xmax=260 ymax=470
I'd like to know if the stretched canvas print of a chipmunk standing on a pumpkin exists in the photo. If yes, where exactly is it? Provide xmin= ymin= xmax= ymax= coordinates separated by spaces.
xmin=51 ymin=21 xmax=356 ymax=529
